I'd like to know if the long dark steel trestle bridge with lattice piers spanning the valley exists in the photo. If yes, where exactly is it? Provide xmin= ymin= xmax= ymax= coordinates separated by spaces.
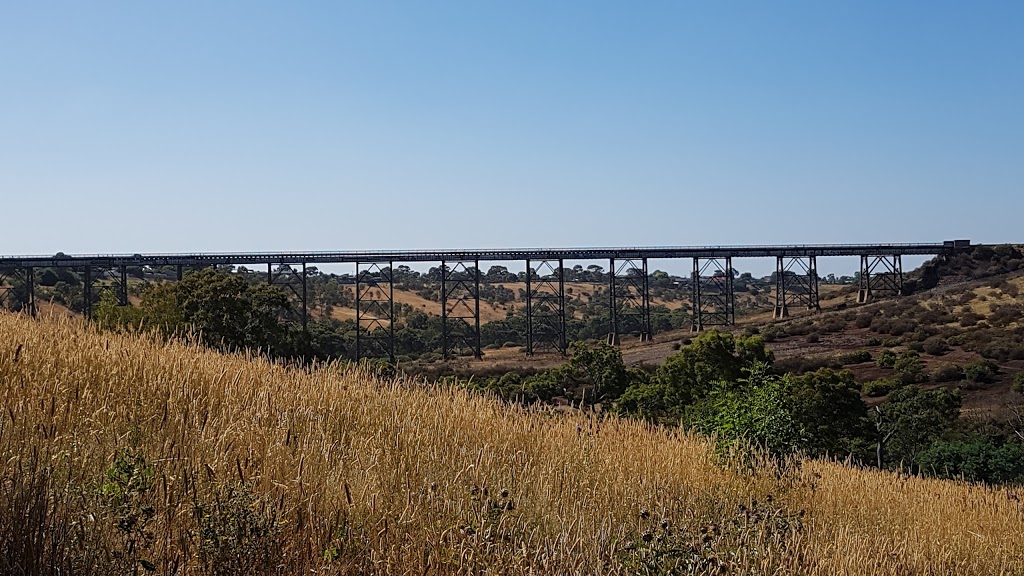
xmin=0 ymin=240 xmax=971 ymax=360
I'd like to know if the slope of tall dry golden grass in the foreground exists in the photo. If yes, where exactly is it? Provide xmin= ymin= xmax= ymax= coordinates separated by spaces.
xmin=0 ymin=314 xmax=1024 ymax=574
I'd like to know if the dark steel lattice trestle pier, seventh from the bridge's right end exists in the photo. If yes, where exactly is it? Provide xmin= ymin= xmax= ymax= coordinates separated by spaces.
xmin=355 ymin=262 xmax=394 ymax=362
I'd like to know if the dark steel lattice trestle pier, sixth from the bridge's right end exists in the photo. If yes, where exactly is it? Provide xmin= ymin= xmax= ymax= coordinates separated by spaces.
xmin=441 ymin=260 xmax=482 ymax=360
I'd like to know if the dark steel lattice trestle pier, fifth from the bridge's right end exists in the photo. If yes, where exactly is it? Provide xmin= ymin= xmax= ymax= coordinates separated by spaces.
xmin=526 ymin=259 xmax=568 ymax=355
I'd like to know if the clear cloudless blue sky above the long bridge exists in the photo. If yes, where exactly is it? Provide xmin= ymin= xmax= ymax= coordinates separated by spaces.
xmin=0 ymin=1 xmax=1024 ymax=268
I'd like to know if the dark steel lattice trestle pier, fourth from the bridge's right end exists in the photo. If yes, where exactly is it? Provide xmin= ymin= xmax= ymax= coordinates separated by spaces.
xmin=608 ymin=257 xmax=651 ymax=345
